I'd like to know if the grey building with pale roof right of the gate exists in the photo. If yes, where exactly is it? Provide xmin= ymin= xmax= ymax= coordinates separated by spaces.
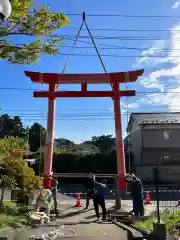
xmin=127 ymin=112 xmax=180 ymax=183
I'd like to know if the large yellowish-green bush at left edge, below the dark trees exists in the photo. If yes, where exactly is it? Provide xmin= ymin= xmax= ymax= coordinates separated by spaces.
xmin=0 ymin=137 xmax=41 ymax=204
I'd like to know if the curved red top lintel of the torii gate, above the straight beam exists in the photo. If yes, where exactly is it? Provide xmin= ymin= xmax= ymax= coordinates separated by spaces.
xmin=25 ymin=70 xmax=144 ymax=84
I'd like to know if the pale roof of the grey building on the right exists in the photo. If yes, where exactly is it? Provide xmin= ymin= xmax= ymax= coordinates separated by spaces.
xmin=127 ymin=112 xmax=180 ymax=132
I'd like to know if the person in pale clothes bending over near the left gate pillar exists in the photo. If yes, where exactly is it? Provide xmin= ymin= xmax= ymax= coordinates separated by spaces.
xmin=36 ymin=187 xmax=52 ymax=217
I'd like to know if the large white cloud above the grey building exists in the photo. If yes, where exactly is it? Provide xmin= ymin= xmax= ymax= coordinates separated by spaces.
xmin=134 ymin=23 xmax=180 ymax=111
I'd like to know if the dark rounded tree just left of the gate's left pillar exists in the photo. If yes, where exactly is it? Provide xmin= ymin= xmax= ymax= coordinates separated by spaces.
xmin=29 ymin=123 xmax=46 ymax=152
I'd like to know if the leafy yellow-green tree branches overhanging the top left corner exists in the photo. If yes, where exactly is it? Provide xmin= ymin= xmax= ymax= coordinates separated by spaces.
xmin=0 ymin=0 xmax=69 ymax=64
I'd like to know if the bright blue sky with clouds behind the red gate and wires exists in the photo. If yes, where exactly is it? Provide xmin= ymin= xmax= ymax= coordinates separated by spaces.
xmin=0 ymin=0 xmax=180 ymax=142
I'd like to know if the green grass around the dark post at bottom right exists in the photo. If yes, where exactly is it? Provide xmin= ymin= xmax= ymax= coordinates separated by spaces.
xmin=134 ymin=210 xmax=180 ymax=235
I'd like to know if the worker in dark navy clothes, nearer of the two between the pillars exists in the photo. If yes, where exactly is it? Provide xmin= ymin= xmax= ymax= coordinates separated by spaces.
xmin=93 ymin=176 xmax=109 ymax=220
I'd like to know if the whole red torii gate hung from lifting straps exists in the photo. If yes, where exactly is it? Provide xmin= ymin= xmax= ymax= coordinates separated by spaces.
xmin=25 ymin=70 xmax=144 ymax=192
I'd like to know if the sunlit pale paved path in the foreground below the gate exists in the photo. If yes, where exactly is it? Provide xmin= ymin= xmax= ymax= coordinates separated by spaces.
xmin=0 ymin=204 xmax=127 ymax=240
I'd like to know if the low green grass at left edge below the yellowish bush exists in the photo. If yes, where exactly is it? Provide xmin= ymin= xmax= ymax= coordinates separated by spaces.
xmin=0 ymin=201 xmax=26 ymax=229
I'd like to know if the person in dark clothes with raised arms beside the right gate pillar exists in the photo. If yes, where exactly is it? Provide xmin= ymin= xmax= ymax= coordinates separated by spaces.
xmin=125 ymin=174 xmax=144 ymax=217
